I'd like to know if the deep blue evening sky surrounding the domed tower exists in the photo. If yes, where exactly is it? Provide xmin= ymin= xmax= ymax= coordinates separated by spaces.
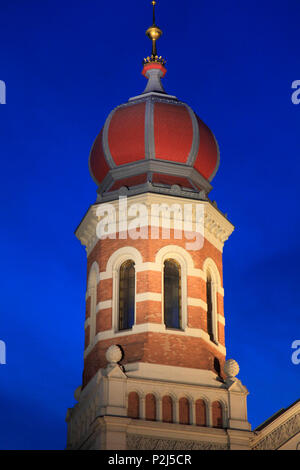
xmin=0 ymin=0 xmax=300 ymax=449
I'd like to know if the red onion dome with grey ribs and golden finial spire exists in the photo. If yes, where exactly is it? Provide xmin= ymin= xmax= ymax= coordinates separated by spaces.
xmin=89 ymin=1 xmax=219 ymax=197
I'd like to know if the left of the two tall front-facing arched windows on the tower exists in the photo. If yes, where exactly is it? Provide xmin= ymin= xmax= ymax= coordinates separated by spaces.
xmin=119 ymin=260 xmax=135 ymax=330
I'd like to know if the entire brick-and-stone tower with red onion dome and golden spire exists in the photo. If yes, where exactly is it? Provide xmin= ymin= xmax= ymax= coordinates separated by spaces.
xmin=67 ymin=1 xmax=251 ymax=450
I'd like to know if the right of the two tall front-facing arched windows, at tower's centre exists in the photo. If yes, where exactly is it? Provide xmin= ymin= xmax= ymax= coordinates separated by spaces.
xmin=164 ymin=259 xmax=181 ymax=329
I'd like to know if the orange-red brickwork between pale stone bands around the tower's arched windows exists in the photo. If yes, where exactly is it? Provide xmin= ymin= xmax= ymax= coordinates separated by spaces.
xmin=83 ymin=232 xmax=225 ymax=385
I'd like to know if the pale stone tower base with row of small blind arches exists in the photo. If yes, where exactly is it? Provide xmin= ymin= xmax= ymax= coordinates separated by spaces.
xmin=67 ymin=363 xmax=252 ymax=450
